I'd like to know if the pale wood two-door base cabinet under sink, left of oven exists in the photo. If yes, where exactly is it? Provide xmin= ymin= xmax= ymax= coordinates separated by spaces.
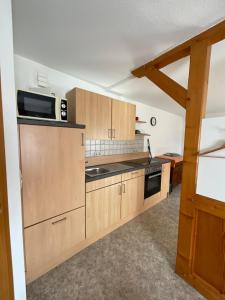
xmin=86 ymin=170 xmax=144 ymax=239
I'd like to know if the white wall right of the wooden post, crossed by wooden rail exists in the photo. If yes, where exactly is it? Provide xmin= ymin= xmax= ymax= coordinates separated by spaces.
xmin=197 ymin=117 xmax=225 ymax=202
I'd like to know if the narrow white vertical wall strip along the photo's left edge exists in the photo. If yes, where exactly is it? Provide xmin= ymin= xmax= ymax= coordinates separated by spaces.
xmin=0 ymin=0 xmax=26 ymax=300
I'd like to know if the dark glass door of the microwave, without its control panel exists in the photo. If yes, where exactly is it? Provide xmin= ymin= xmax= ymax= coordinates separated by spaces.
xmin=17 ymin=91 xmax=56 ymax=120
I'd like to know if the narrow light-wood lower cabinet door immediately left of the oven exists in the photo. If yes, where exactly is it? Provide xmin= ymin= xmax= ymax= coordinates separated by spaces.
xmin=121 ymin=176 xmax=144 ymax=219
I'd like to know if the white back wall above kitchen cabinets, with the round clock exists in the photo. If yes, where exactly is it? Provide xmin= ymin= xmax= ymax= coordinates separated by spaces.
xmin=15 ymin=55 xmax=184 ymax=155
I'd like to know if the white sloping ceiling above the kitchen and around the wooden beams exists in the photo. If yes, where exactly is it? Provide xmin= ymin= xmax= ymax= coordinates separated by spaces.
xmin=13 ymin=0 xmax=225 ymax=114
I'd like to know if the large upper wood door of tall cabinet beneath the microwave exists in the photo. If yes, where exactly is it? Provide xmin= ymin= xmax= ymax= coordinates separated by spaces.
xmin=20 ymin=125 xmax=85 ymax=227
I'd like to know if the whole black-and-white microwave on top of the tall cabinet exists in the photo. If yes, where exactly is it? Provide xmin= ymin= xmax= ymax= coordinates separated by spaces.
xmin=17 ymin=90 xmax=68 ymax=122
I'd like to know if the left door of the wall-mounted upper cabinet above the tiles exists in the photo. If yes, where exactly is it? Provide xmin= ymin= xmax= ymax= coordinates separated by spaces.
xmin=76 ymin=89 xmax=111 ymax=140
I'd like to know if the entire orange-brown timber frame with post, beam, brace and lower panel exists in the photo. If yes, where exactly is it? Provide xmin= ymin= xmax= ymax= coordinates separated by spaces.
xmin=132 ymin=20 xmax=225 ymax=300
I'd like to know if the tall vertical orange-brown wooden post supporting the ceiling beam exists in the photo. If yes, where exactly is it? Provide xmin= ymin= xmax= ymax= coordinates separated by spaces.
xmin=176 ymin=41 xmax=211 ymax=276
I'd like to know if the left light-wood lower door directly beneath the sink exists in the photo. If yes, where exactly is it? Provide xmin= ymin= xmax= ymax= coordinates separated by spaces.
xmin=86 ymin=183 xmax=121 ymax=238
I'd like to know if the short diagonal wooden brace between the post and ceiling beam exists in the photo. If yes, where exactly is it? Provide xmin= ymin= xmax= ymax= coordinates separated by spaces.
xmin=145 ymin=68 xmax=187 ymax=108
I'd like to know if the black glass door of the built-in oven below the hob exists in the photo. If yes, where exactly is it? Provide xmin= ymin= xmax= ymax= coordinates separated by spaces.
xmin=145 ymin=171 xmax=162 ymax=199
